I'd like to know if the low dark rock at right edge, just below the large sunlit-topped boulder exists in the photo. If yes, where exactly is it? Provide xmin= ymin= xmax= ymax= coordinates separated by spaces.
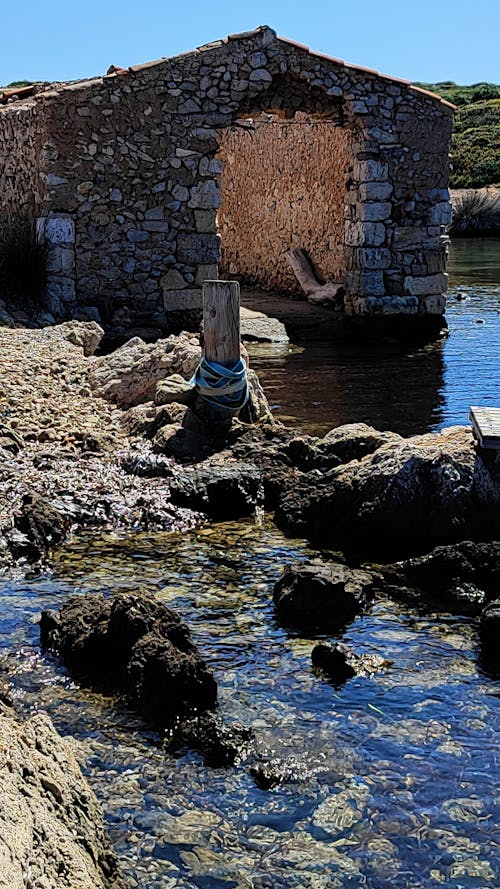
xmin=384 ymin=540 xmax=500 ymax=614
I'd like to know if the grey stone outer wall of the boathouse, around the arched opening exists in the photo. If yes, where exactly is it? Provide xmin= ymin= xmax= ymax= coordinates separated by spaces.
xmin=0 ymin=28 xmax=453 ymax=329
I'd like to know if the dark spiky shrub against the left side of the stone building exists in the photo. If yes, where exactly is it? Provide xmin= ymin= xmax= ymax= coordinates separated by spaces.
xmin=0 ymin=214 xmax=47 ymax=305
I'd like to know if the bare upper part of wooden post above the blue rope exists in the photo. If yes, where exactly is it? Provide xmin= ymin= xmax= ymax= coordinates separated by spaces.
xmin=203 ymin=281 xmax=240 ymax=367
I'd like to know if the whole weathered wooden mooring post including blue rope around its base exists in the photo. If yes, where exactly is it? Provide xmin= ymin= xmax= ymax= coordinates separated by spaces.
xmin=195 ymin=281 xmax=248 ymax=435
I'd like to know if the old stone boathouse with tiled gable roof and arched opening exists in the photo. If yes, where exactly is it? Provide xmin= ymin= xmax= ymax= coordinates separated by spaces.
xmin=0 ymin=27 xmax=453 ymax=329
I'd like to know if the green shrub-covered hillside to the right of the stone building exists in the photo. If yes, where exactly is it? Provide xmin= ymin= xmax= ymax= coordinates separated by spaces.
xmin=419 ymin=81 xmax=500 ymax=188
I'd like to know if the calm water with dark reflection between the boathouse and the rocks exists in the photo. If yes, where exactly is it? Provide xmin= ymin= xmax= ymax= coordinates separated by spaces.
xmin=250 ymin=239 xmax=500 ymax=435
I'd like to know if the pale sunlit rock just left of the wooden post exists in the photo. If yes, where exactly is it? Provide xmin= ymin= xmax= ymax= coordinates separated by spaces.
xmin=90 ymin=333 xmax=201 ymax=409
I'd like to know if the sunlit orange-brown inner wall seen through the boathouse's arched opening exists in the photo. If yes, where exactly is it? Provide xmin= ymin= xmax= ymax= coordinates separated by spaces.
xmin=217 ymin=112 xmax=350 ymax=291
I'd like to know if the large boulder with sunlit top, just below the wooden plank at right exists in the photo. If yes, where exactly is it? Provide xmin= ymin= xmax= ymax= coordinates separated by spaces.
xmin=276 ymin=427 xmax=500 ymax=560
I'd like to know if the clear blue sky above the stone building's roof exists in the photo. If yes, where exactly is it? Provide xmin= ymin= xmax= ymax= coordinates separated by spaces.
xmin=0 ymin=0 xmax=500 ymax=85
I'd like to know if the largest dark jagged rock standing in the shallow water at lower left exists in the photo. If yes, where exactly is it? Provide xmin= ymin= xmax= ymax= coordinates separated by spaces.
xmin=40 ymin=592 xmax=217 ymax=726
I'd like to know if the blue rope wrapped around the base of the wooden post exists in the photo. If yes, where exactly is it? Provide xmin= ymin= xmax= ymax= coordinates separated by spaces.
xmin=191 ymin=357 xmax=248 ymax=411
